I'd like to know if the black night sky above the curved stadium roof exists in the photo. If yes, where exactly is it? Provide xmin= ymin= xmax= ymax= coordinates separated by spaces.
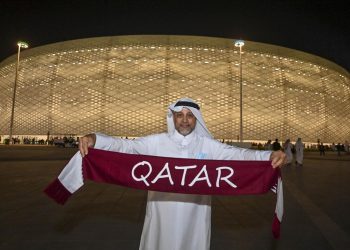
xmin=0 ymin=0 xmax=350 ymax=71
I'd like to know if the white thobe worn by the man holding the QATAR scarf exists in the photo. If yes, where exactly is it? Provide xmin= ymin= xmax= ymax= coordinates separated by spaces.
xmin=95 ymin=131 xmax=271 ymax=250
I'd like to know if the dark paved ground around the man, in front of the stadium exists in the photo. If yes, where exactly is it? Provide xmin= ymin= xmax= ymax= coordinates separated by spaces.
xmin=0 ymin=146 xmax=350 ymax=250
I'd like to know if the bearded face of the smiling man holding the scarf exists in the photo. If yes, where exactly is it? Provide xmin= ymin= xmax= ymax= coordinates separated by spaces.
xmin=173 ymin=108 xmax=197 ymax=136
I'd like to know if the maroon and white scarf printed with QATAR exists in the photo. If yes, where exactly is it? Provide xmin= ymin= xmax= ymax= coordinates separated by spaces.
xmin=44 ymin=149 xmax=283 ymax=238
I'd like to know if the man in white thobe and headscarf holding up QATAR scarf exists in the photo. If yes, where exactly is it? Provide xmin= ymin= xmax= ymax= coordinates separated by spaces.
xmin=79 ymin=98 xmax=286 ymax=250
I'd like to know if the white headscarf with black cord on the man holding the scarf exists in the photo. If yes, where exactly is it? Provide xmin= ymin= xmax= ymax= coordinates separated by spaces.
xmin=167 ymin=98 xmax=213 ymax=138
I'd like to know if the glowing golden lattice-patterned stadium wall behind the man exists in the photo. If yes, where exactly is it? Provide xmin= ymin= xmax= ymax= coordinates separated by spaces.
xmin=0 ymin=36 xmax=350 ymax=143
